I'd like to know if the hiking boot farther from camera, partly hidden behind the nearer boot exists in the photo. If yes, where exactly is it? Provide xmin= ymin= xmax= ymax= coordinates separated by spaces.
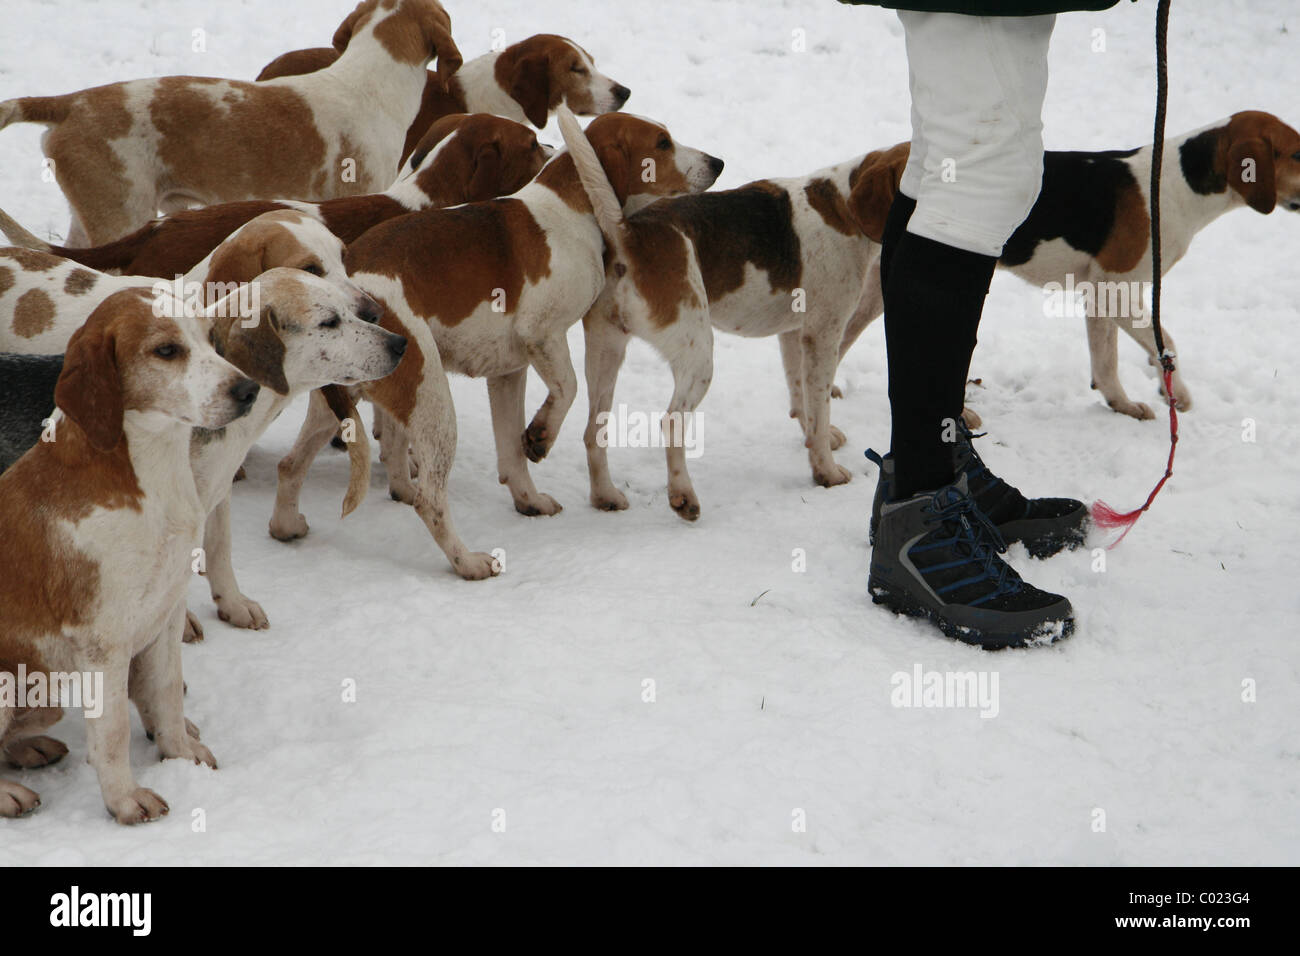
xmin=866 ymin=419 xmax=1088 ymax=558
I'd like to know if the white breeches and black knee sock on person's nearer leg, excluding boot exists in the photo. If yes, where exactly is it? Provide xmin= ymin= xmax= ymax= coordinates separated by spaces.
xmin=881 ymin=10 xmax=1054 ymax=498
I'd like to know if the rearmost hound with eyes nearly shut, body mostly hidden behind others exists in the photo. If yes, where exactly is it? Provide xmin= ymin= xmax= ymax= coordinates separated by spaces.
xmin=257 ymin=34 xmax=632 ymax=164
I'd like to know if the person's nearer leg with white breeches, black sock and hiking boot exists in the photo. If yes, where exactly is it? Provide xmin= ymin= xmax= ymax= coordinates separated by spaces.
xmin=870 ymin=12 xmax=1074 ymax=648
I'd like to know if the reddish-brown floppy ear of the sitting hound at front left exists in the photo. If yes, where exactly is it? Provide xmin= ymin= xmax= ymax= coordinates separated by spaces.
xmin=55 ymin=323 xmax=122 ymax=451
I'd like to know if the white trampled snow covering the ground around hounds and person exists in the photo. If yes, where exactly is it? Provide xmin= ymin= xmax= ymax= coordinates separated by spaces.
xmin=0 ymin=0 xmax=1300 ymax=865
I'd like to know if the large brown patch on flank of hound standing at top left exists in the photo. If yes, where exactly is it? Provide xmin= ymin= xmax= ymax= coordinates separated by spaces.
xmin=150 ymin=77 xmax=335 ymax=200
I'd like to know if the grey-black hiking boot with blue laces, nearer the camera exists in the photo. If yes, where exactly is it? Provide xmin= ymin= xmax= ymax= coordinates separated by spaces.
xmin=867 ymin=475 xmax=1074 ymax=650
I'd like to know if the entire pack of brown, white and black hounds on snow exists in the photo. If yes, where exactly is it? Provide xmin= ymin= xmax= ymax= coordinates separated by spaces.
xmin=0 ymin=0 xmax=1300 ymax=823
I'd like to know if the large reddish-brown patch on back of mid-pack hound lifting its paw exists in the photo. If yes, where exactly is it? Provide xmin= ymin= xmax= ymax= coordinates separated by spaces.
xmin=345 ymin=196 xmax=548 ymax=327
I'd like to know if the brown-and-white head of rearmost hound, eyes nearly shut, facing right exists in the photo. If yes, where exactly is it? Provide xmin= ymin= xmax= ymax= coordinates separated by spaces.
xmin=495 ymin=34 xmax=632 ymax=127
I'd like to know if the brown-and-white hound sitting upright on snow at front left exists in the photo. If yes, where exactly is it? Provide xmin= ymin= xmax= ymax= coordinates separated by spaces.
xmin=0 ymin=289 xmax=259 ymax=823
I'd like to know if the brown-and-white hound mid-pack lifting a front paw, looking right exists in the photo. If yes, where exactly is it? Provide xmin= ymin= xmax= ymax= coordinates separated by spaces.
xmin=270 ymin=107 xmax=723 ymax=579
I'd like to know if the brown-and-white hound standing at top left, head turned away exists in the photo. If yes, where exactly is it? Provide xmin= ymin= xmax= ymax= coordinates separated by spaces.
xmin=0 ymin=0 xmax=460 ymax=246
